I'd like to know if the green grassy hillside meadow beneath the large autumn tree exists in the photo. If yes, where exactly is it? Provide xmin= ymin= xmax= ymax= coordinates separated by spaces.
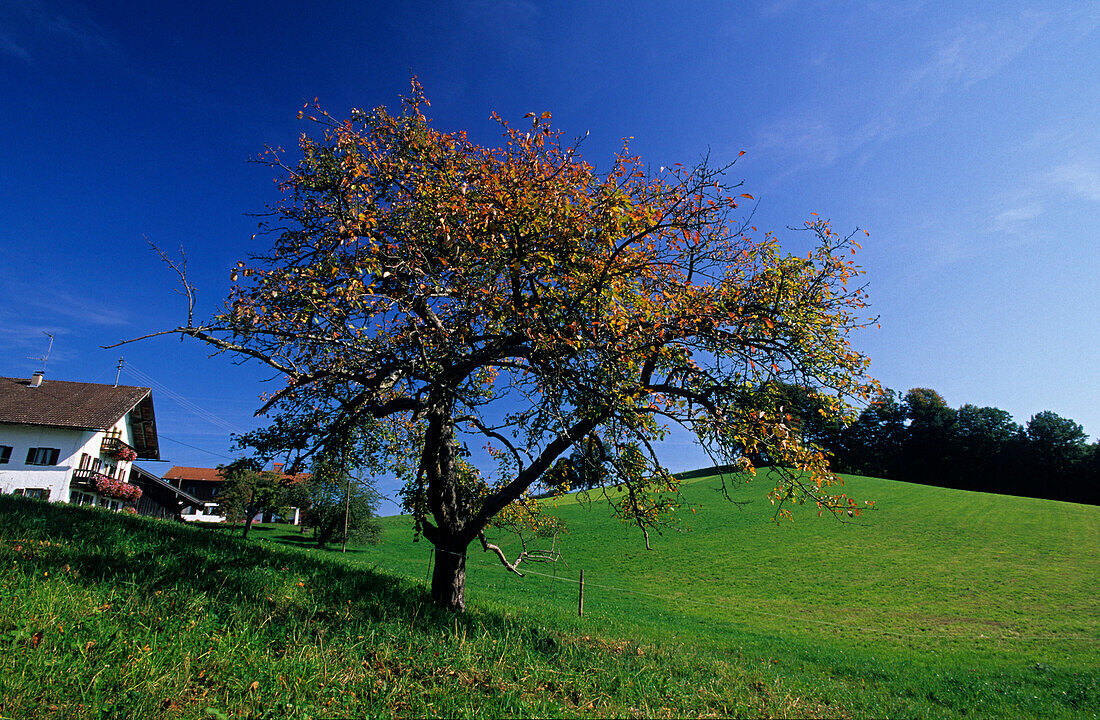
xmin=0 ymin=470 xmax=1100 ymax=718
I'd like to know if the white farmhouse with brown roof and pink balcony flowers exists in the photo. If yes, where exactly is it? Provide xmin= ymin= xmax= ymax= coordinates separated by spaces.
xmin=0 ymin=373 xmax=160 ymax=510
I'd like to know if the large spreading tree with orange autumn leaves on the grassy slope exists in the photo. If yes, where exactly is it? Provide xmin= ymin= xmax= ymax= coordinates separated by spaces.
xmin=137 ymin=82 xmax=873 ymax=609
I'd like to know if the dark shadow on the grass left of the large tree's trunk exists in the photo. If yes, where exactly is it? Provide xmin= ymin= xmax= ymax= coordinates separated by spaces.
xmin=0 ymin=496 xmax=558 ymax=655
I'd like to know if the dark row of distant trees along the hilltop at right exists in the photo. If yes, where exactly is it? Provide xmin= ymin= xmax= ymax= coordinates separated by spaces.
xmin=774 ymin=385 xmax=1100 ymax=505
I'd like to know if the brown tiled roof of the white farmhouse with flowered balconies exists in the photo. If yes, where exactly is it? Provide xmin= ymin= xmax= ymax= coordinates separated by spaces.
xmin=0 ymin=377 xmax=152 ymax=430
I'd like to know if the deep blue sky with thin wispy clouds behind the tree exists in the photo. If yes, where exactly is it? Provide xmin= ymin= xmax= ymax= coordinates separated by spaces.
xmin=0 ymin=0 xmax=1100 ymax=512
